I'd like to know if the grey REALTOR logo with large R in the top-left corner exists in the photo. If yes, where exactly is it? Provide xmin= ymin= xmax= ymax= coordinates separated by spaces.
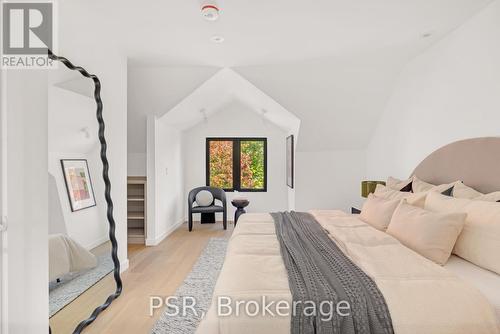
xmin=2 ymin=2 xmax=54 ymax=68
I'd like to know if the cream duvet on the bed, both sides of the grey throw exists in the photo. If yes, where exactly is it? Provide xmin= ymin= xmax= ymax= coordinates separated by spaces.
xmin=197 ymin=211 xmax=499 ymax=334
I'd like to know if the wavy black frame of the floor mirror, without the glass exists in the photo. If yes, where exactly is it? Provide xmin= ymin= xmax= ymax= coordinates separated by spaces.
xmin=48 ymin=50 xmax=123 ymax=334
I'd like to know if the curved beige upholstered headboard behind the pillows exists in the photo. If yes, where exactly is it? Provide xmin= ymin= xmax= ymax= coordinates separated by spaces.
xmin=413 ymin=137 xmax=500 ymax=193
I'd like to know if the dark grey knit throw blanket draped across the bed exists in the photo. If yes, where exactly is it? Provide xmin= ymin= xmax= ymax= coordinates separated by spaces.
xmin=271 ymin=212 xmax=394 ymax=334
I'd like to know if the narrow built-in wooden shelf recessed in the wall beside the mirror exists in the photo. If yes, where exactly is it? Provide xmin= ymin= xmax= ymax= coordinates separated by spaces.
xmin=127 ymin=176 xmax=146 ymax=244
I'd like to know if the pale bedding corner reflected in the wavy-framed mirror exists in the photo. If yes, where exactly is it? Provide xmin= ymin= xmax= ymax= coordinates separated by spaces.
xmin=49 ymin=234 xmax=97 ymax=282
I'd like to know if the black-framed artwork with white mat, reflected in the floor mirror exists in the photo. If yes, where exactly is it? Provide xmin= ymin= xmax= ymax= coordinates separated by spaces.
xmin=61 ymin=159 xmax=96 ymax=212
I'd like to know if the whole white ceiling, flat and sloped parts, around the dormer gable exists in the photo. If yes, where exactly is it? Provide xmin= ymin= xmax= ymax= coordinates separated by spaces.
xmin=60 ymin=0 xmax=492 ymax=152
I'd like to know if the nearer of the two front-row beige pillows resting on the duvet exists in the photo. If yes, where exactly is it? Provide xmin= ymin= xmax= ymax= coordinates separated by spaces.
xmin=387 ymin=201 xmax=467 ymax=265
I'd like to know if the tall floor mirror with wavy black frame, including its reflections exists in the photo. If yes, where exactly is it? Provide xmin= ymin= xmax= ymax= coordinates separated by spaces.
xmin=48 ymin=51 xmax=122 ymax=334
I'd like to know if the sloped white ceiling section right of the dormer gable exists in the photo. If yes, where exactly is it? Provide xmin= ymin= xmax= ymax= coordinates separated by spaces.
xmin=235 ymin=57 xmax=403 ymax=151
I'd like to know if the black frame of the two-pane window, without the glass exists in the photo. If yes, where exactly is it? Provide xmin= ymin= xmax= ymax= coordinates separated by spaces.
xmin=205 ymin=137 xmax=267 ymax=192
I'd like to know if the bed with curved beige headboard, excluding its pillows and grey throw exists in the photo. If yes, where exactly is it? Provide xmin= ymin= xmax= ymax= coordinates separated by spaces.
xmin=197 ymin=138 xmax=500 ymax=334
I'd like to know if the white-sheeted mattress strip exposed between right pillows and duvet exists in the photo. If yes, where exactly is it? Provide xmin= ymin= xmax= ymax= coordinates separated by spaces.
xmin=444 ymin=255 xmax=500 ymax=324
